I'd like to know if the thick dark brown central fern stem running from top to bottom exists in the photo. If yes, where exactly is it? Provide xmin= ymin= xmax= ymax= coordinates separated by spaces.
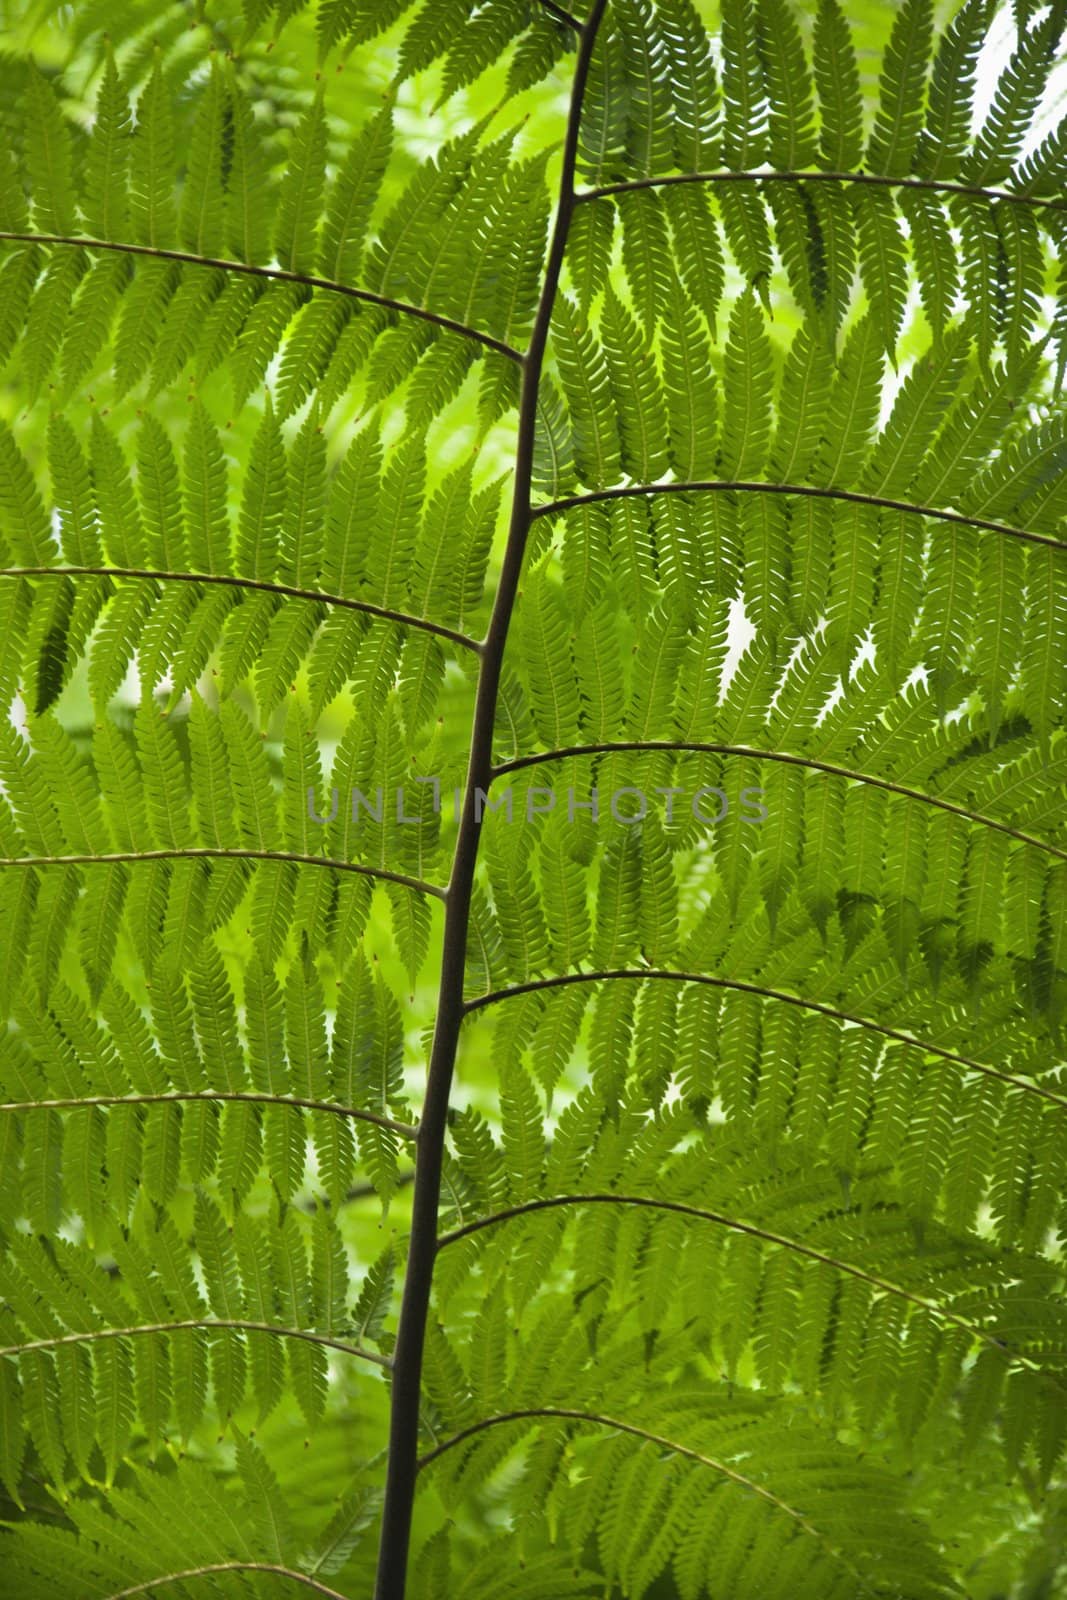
xmin=374 ymin=0 xmax=606 ymax=1600
